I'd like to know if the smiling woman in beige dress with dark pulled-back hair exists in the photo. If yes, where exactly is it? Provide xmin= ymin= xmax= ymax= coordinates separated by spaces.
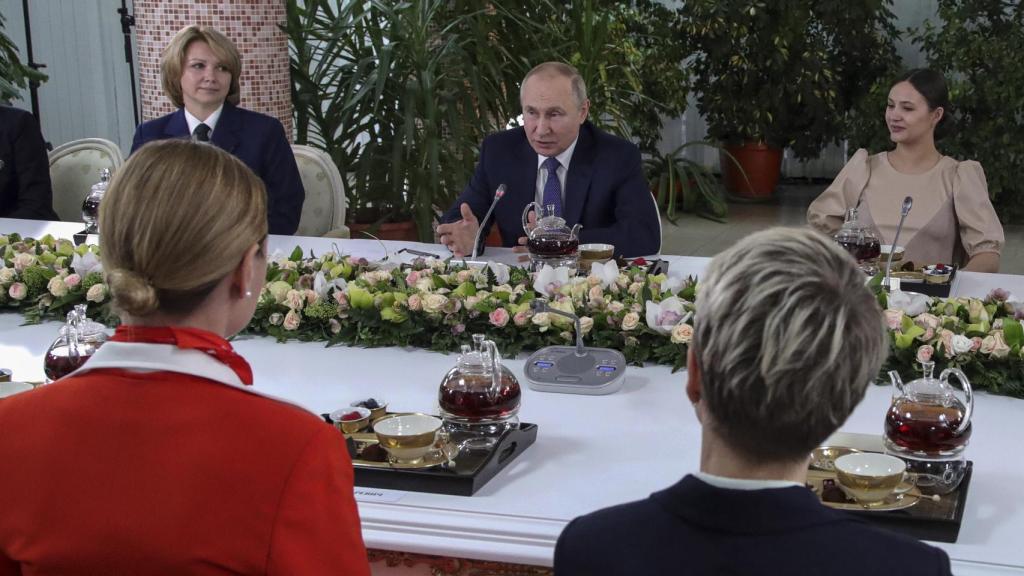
xmin=807 ymin=70 xmax=1004 ymax=272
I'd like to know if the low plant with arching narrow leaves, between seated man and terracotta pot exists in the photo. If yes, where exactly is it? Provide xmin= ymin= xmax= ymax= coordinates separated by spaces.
xmin=644 ymin=141 xmax=729 ymax=223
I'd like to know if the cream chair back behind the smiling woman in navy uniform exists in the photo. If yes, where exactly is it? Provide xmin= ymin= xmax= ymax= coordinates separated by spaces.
xmin=292 ymin=145 xmax=350 ymax=238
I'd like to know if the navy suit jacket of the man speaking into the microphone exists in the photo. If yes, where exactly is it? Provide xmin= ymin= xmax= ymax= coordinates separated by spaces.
xmin=442 ymin=122 xmax=662 ymax=256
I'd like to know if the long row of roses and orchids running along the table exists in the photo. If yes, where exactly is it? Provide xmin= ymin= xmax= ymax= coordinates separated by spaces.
xmin=8 ymin=234 xmax=1024 ymax=398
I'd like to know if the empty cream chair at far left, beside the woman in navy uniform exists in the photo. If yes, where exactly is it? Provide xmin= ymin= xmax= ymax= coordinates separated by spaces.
xmin=49 ymin=138 xmax=124 ymax=222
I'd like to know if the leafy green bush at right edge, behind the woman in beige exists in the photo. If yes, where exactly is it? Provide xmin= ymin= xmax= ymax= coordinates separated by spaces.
xmin=913 ymin=0 xmax=1024 ymax=222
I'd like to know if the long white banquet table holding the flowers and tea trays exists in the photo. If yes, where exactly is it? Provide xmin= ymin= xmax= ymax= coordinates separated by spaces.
xmin=0 ymin=218 xmax=1024 ymax=575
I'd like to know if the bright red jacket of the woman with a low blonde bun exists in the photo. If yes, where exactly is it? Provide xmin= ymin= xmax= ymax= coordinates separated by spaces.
xmin=0 ymin=342 xmax=370 ymax=576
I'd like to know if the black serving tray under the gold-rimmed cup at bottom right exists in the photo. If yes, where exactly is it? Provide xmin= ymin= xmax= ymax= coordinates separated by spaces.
xmin=823 ymin=460 xmax=974 ymax=542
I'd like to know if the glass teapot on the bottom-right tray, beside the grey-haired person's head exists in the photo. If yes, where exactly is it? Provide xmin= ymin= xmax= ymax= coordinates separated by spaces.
xmin=885 ymin=362 xmax=974 ymax=460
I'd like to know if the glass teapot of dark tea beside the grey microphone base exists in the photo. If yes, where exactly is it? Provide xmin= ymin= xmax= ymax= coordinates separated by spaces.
xmin=437 ymin=334 xmax=522 ymax=433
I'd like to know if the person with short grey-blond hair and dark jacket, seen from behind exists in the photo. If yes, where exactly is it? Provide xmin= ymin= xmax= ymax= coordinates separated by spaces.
xmin=555 ymin=229 xmax=950 ymax=576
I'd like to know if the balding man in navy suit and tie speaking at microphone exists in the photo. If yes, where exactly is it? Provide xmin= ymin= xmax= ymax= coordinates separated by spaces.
xmin=437 ymin=63 xmax=662 ymax=256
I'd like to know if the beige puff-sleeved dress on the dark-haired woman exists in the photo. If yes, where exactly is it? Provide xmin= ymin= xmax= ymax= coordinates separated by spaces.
xmin=807 ymin=149 xmax=1004 ymax=265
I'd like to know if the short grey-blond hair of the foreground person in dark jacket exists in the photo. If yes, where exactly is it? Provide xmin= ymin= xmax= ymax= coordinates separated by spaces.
xmin=691 ymin=228 xmax=889 ymax=461
